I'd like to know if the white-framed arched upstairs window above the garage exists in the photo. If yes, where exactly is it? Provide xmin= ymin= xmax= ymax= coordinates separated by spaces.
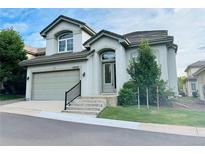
xmin=58 ymin=32 xmax=73 ymax=52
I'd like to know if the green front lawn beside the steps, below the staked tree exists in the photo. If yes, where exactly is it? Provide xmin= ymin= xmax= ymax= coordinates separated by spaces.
xmin=98 ymin=106 xmax=205 ymax=127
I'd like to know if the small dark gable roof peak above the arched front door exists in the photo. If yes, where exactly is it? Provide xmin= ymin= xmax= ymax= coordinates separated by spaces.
xmin=83 ymin=29 xmax=130 ymax=47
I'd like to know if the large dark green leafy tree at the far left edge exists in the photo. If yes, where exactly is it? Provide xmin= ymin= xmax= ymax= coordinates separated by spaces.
xmin=0 ymin=29 xmax=27 ymax=94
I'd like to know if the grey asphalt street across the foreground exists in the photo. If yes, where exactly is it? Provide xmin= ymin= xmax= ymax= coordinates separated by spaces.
xmin=0 ymin=113 xmax=205 ymax=146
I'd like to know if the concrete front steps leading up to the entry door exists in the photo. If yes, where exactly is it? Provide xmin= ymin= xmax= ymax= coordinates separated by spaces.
xmin=63 ymin=97 xmax=107 ymax=116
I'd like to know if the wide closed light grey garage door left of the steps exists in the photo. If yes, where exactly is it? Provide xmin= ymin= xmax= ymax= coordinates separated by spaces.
xmin=32 ymin=70 xmax=80 ymax=100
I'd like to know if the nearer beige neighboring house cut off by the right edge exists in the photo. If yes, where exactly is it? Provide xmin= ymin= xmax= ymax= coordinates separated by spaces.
xmin=193 ymin=65 xmax=205 ymax=100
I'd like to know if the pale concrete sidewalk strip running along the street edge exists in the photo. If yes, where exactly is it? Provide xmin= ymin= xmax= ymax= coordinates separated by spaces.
xmin=0 ymin=102 xmax=205 ymax=137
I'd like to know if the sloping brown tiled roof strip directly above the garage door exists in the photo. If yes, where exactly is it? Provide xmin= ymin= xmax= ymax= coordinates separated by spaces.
xmin=19 ymin=50 xmax=94 ymax=66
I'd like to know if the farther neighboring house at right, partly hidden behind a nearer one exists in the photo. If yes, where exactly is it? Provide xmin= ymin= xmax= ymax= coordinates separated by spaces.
xmin=184 ymin=61 xmax=205 ymax=97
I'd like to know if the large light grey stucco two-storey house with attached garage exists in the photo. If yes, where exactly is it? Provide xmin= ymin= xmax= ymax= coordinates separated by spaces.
xmin=20 ymin=15 xmax=178 ymax=103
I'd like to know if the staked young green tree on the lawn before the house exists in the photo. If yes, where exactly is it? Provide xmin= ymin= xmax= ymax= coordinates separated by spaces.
xmin=127 ymin=41 xmax=162 ymax=103
